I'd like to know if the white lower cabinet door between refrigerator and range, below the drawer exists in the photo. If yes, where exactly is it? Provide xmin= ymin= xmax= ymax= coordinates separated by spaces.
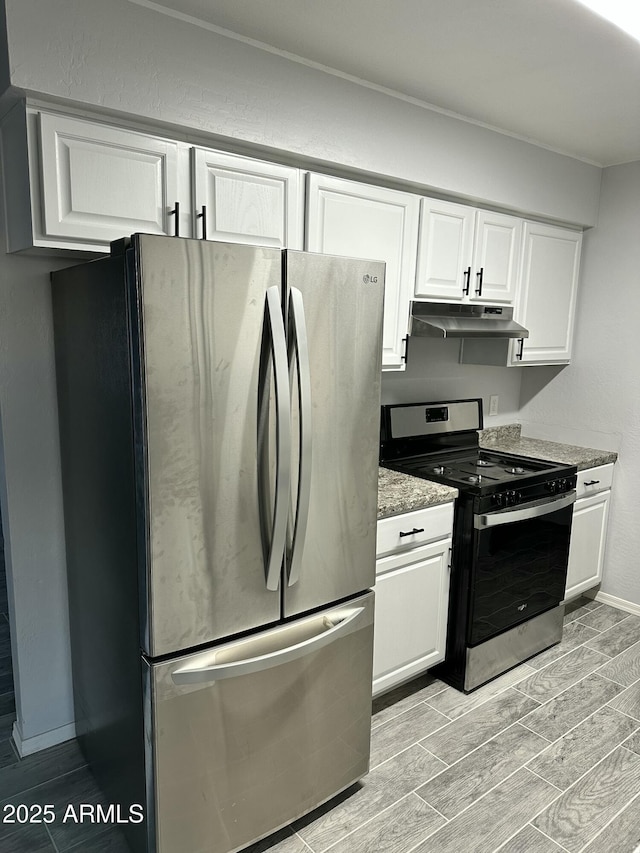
xmin=373 ymin=539 xmax=451 ymax=696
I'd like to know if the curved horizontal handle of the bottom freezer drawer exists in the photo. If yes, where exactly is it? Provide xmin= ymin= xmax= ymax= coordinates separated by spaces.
xmin=171 ymin=607 xmax=365 ymax=684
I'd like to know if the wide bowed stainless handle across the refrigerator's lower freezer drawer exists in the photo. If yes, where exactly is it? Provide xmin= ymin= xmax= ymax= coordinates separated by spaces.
xmin=171 ymin=607 xmax=366 ymax=685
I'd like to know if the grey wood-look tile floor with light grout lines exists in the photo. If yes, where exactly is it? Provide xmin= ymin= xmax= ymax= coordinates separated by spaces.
xmin=0 ymin=599 xmax=640 ymax=853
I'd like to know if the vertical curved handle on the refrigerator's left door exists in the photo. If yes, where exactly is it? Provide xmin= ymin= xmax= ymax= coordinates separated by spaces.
xmin=258 ymin=286 xmax=291 ymax=590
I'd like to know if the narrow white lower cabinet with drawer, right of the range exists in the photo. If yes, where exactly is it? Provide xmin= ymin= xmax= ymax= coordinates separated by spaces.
xmin=564 ymin=465 xmax=613 ymax=600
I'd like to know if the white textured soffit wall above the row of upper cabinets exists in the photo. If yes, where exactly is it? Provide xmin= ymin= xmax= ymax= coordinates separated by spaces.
xmin=5 ymin=0 xmax=600 ymax=224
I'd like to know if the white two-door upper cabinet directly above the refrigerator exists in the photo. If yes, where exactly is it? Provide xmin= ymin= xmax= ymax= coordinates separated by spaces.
xmin=2 ymin=104 xmax=304 ymax=252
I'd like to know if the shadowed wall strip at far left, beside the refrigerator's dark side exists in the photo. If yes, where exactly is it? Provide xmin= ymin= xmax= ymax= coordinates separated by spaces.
xmin=0 ymin=168 xmax=73 ymax=751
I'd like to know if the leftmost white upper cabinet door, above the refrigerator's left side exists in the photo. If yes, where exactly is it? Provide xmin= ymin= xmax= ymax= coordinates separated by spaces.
xmin=34 ymin=113 xmax=190 ymax=251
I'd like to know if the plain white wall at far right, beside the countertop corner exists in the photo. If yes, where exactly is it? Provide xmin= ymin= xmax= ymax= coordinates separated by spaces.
xmin=522 ymin=162 xmax=640 ymax=604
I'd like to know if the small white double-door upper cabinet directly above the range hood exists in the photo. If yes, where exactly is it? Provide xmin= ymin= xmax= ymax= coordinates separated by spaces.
xmin=415 ymin=198 xmax=522 ymax=304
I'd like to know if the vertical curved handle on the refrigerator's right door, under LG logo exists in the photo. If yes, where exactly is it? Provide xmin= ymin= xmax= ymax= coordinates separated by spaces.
xmin=287 ymin=287 xmax=312 ymax=586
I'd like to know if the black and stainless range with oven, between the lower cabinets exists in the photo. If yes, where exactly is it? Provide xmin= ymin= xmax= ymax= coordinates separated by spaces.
xmin=380 ymin=399 xmax=577 ymax=692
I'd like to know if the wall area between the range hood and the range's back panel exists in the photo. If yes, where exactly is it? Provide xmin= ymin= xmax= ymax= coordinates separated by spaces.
xmin=382 ymin=338 xmax=522 ymax=426
